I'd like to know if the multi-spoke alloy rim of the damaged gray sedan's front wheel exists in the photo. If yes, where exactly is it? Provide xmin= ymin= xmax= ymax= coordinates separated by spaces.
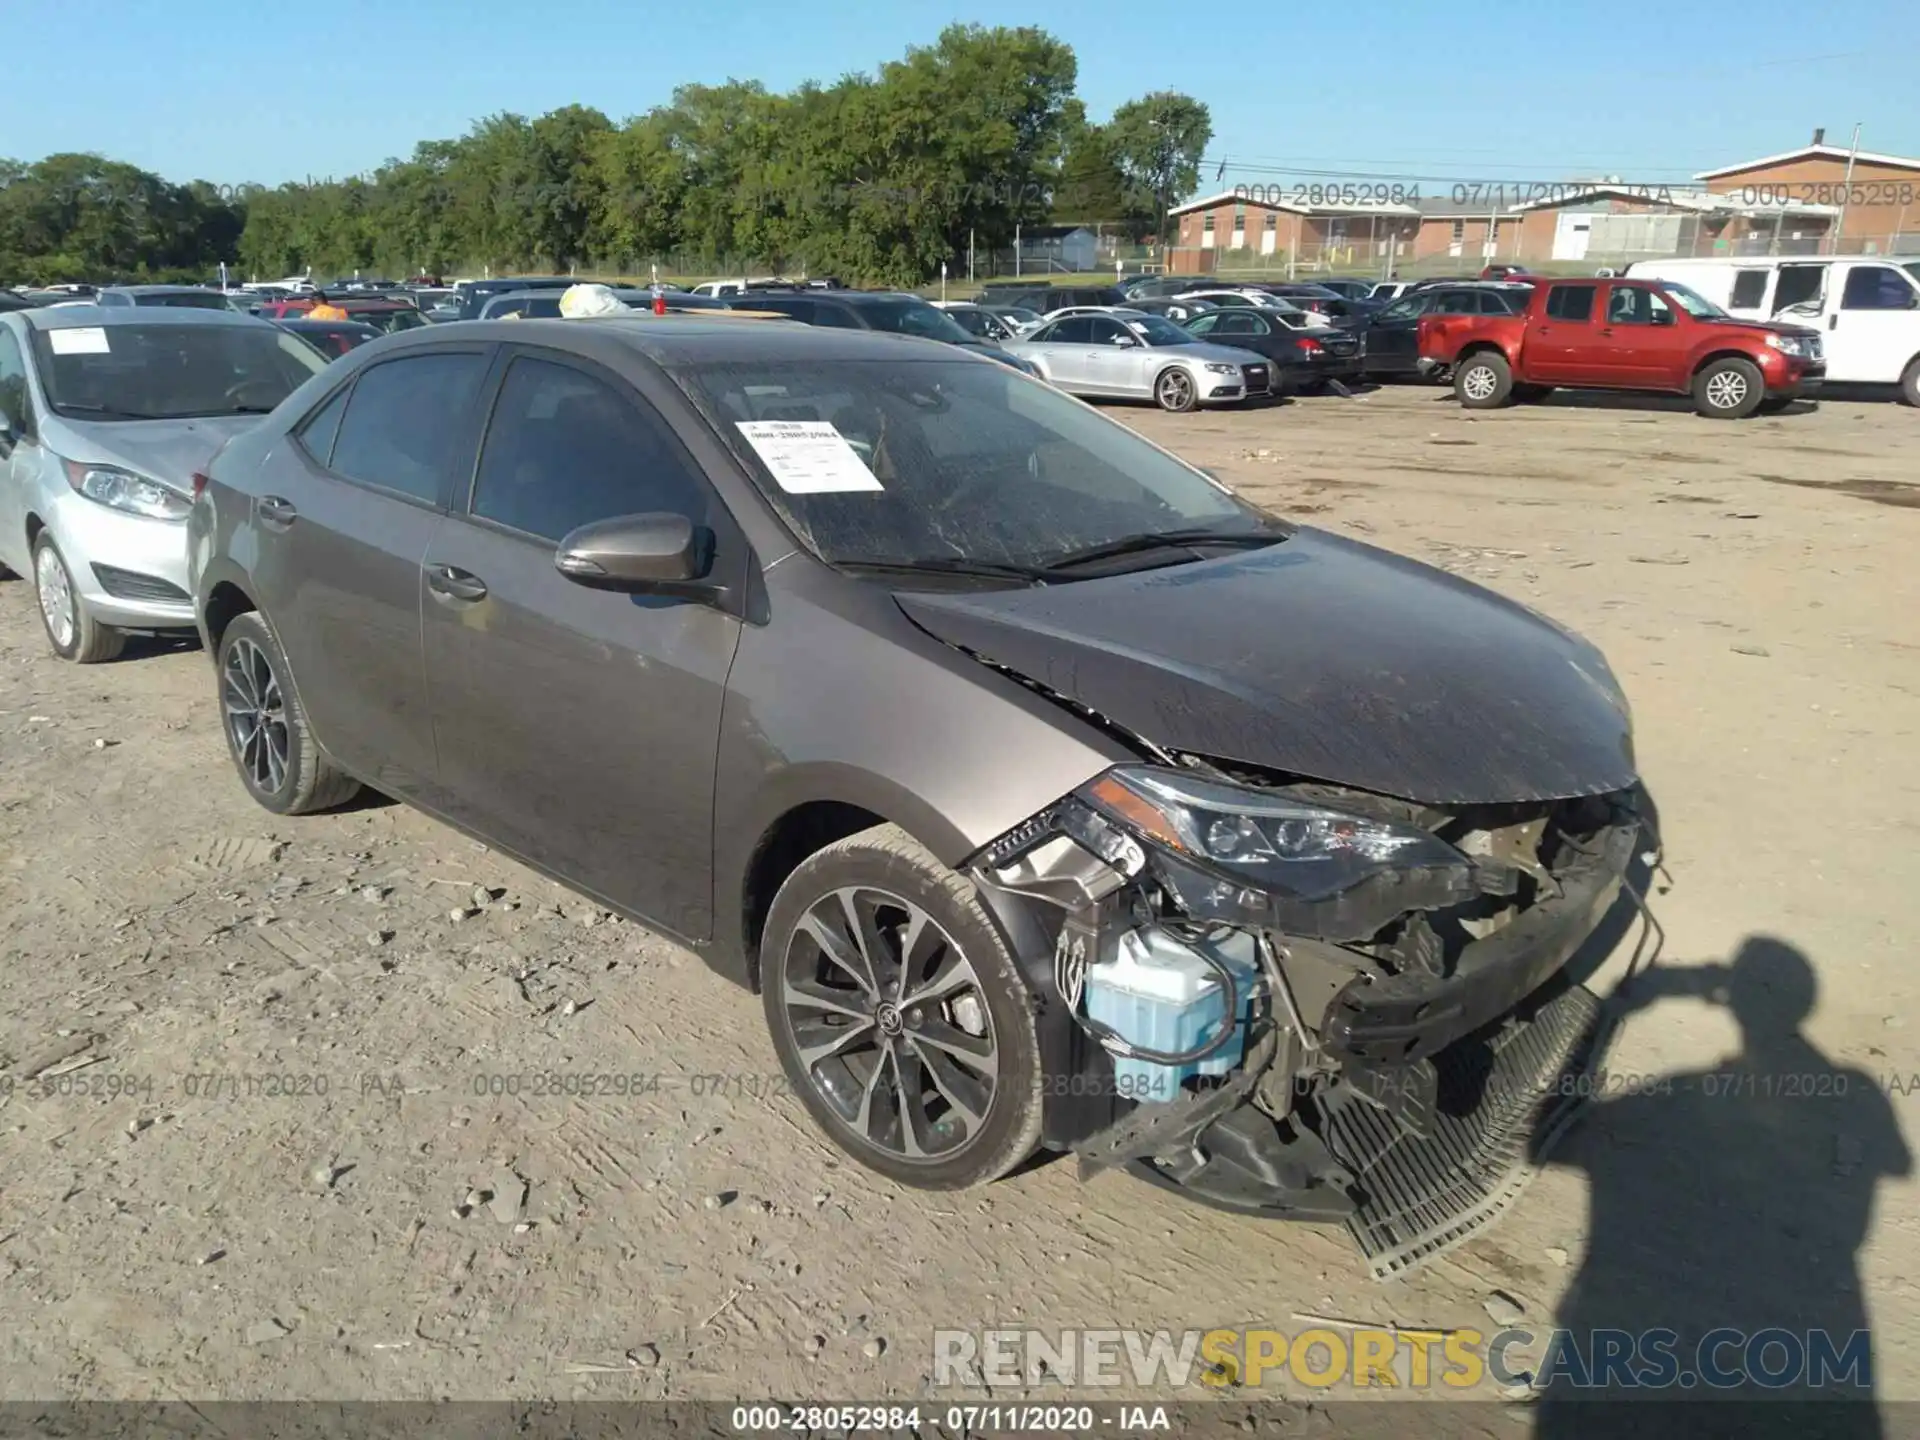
xmin=780 ymin=885 xmax=1000 ymax=1162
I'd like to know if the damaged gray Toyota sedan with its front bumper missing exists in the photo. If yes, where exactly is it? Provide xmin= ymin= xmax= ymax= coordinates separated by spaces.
xmin=188 ymin=317 xmax=1640 ymax=1273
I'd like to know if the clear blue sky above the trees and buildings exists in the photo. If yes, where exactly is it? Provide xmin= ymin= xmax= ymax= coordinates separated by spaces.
xmin=0 ymin=0 xmax=1920 ymax=190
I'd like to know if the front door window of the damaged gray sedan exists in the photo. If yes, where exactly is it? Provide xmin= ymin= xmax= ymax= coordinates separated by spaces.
xmin=472 ymin=357 xmax=707 ymax=541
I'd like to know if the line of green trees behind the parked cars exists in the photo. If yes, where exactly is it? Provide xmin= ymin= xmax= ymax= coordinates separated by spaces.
xmin=0 ymin=25 xmax=1212 ymax=284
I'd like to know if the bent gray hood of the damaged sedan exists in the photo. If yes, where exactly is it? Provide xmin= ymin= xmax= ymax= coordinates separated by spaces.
xmin=895 ymin=528 xmax=1636 ymax=804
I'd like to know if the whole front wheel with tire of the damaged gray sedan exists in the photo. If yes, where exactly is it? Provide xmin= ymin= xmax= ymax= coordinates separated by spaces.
xmin=760 ymin=826 xmax=1043 ymax=1190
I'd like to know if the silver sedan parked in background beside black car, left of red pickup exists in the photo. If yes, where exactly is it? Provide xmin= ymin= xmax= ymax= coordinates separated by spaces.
xmin=1006 ymin=307 xmax=1273 ymax=411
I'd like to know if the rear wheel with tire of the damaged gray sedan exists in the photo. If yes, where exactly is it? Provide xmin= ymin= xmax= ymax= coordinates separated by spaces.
xmin=217 ymin=611 xmax=359 ymax=814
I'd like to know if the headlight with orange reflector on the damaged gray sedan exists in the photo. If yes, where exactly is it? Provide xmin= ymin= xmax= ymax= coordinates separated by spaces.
xmin=1079 ymin=766 xmax=1471 ymax=899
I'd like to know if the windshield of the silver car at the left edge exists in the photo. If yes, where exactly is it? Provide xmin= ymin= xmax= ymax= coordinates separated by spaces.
xmin=33 ymin=321 xmax=326 ymax=420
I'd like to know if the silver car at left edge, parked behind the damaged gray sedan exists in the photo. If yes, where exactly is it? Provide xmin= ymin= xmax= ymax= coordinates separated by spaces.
xmin=0 ymin=305 xmax=326 ymax=664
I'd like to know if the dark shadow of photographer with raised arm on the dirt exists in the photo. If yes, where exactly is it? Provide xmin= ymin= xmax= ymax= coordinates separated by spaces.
xmin=1536 ymin=935 xmax=1912 ymax=1440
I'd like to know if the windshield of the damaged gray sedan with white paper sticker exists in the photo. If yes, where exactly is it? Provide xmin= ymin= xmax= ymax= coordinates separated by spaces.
xmin=674 ymin=359 xmax=1277 ymax=568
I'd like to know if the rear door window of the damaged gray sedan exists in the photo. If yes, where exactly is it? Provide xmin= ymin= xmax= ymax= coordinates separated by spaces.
xmin=328 ymin=355 xmax=486 ymax=505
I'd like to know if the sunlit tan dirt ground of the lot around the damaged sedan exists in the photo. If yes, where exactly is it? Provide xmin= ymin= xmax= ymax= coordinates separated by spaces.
xmin=0 ymin=378 xmax=1920 ymax=1427
